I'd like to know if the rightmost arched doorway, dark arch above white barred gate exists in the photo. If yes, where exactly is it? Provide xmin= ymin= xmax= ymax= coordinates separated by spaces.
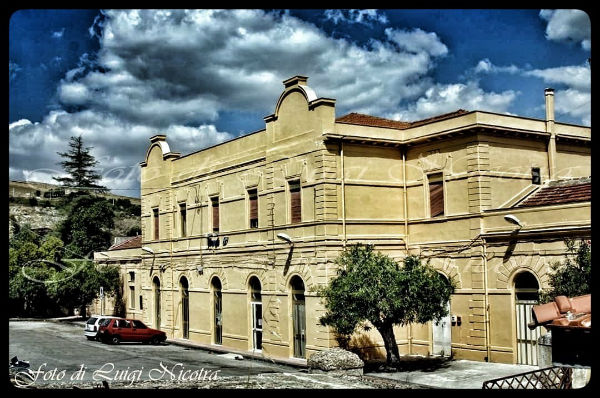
xmin=514 ymin=271 xmax=540 ymax=366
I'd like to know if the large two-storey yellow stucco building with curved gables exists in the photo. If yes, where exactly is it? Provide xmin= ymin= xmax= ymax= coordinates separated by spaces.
xmin=96 ymin=76 xmax=591 ymax=365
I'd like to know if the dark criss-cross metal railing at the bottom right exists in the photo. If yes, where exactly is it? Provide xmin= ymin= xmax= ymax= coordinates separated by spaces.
xmin=482 ymin=366 xmax=573 ymax=390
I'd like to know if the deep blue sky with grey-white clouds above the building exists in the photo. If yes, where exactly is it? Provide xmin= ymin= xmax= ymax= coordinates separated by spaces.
xmin=9 ymin=10 xmax=591 ymax=196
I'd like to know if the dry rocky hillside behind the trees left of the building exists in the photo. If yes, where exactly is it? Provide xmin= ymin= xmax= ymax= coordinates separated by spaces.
xmin=8 ymin=181 xmax=141 ymax=243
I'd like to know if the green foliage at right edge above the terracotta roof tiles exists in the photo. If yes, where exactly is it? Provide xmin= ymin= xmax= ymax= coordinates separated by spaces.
xmin=540 ymin=239 xmax=592 ymax=303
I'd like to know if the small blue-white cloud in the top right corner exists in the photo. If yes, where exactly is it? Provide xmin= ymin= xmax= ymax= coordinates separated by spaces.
xmin=540 ymin=10 xmax=592 ymax=50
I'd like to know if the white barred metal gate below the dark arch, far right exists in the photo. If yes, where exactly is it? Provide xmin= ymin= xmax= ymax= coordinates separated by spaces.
xmin=515 ymin=300 xmax=540 ymax=366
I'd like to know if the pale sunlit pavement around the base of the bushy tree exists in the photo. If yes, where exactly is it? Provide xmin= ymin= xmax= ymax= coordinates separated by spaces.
xmin=365 ymin=357 xmax=539 ymax=390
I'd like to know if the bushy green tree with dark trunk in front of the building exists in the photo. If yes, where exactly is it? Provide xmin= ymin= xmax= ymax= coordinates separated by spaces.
xmin=317 ymin=244 xmax=454 ymax=366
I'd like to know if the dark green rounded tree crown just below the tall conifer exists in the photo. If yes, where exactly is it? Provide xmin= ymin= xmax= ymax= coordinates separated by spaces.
xmin=59 ymin=195 xmax=114 ymax=258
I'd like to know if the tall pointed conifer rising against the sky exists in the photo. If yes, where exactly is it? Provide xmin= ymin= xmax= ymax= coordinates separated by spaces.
xmin=52 ymin=136 xmax=107 ymax=192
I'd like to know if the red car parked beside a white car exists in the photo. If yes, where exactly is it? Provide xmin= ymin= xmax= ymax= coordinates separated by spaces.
xmin=98 ymin=318 xmax=167 ymax=344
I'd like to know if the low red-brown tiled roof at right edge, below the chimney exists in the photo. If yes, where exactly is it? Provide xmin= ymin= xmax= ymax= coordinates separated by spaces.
xmin=518 ymin=179 xmax=592 ymax=207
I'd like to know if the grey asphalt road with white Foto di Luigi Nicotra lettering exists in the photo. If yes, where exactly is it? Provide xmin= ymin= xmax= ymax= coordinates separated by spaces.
xmin=8 ymin=321 xmax=297 ymax=385
